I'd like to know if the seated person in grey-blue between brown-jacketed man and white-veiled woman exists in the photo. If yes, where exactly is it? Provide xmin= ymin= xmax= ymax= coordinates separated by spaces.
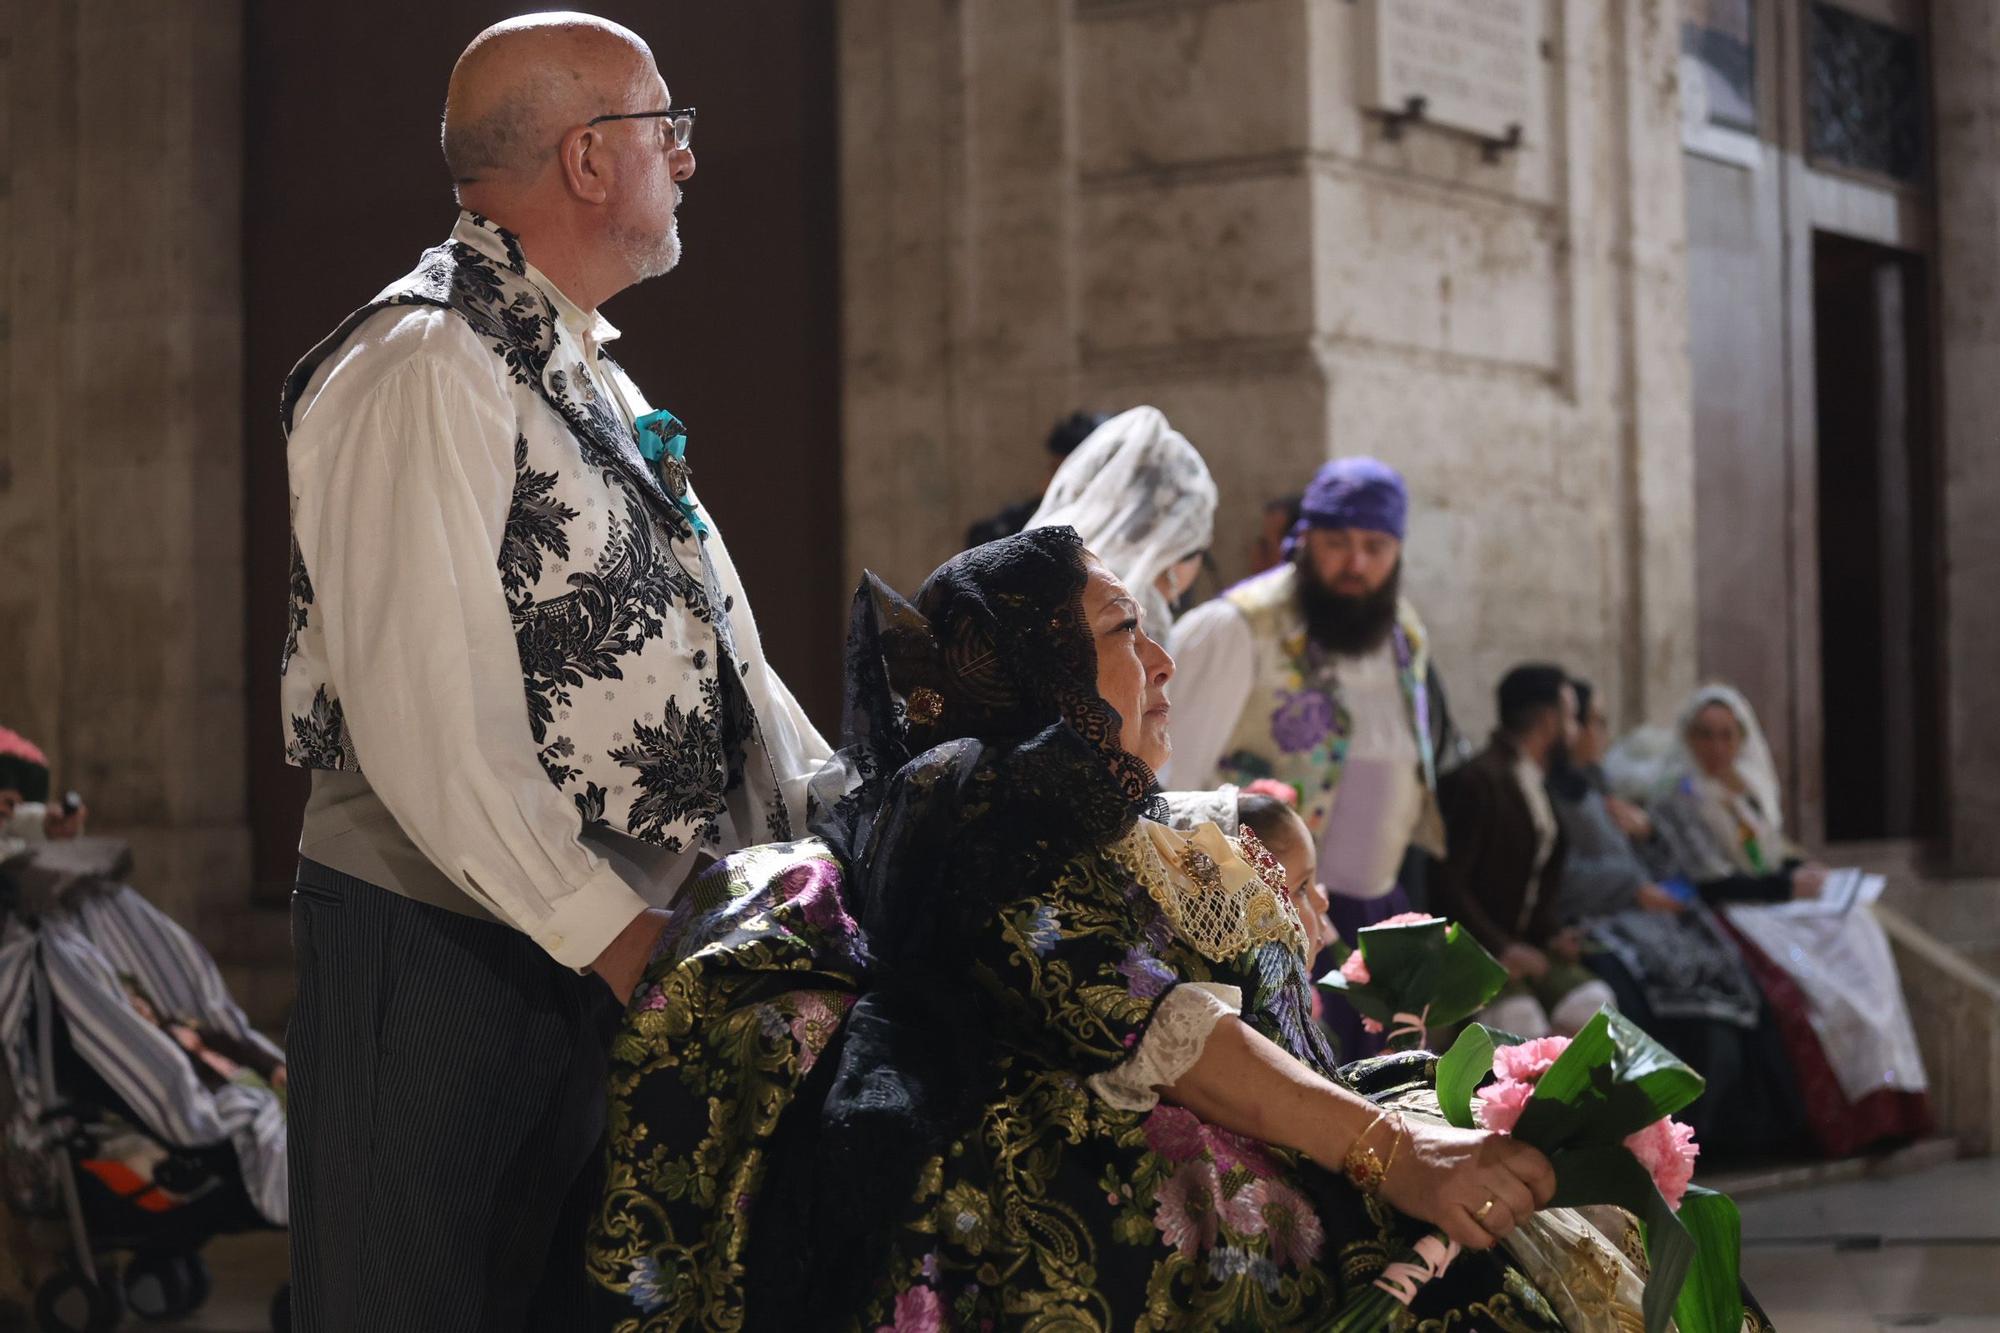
xmin=1548 ymin=679 xmax=1804 ymax=1161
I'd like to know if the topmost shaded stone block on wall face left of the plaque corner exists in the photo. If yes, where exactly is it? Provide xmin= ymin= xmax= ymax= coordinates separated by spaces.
xmin=1076 ymin=0 xmax=1312 ymax=176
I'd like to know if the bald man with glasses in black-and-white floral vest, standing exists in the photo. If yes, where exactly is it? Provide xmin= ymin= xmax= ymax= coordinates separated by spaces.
xmin=284 ymin=14 xmax=828 ymax=1333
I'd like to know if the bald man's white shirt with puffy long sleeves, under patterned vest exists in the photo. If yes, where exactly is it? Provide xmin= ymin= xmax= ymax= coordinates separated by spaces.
xmin=288 ymin=214 xmax=828 ymax=969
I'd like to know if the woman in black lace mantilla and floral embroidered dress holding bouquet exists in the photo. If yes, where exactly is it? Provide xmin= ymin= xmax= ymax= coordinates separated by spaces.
xmin=588 ymin=528 xmax=1680 ymax=1333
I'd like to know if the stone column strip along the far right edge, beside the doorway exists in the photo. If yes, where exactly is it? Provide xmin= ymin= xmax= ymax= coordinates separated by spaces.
xmin=1930 ymin=0 xmax=2000 ymax=875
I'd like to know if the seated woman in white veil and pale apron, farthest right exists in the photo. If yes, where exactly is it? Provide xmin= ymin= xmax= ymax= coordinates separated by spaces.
xmin=1648 ymin=685 xmax=1930 ymax=1157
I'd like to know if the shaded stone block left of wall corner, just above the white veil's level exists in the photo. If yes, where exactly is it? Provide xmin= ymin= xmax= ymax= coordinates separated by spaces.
xmin=1078 ymin=176 xmax=1312 ymax=358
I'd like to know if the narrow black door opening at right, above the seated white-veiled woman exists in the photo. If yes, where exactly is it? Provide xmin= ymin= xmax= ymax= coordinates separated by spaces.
xmin=1812 ymin=232 xmax=1944 ymax=841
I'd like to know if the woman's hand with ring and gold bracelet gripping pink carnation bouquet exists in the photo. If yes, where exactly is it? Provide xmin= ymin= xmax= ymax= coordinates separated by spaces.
xmin=1368 ymin=1117 xmax=1556 ymax=1249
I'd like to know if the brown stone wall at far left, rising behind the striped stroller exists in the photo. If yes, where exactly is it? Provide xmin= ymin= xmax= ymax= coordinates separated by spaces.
xmin=0 ymin=0 xmax=248 ymax=921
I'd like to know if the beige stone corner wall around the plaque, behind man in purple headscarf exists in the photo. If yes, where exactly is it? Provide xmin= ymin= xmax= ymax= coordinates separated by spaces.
xmin=840 ymin=0 xmax=1694 ymax=735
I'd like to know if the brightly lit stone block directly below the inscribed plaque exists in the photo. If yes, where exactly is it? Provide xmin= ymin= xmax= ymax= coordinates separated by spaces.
xmin=1312 ymin=168 xmax=1566 ymax=370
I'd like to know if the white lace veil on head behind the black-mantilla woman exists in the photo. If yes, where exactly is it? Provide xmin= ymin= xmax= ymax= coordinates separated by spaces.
xmin=1028 ymin=406 xmax=1216 ymax=638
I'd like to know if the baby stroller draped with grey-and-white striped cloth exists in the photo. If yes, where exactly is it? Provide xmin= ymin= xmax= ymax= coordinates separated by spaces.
xmin=0 ymin=839 xmax=290 ymax=1333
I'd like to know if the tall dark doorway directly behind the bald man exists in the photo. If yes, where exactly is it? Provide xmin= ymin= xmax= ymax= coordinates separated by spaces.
xmin=244 ymin=0 xmax=846 ymax=895
